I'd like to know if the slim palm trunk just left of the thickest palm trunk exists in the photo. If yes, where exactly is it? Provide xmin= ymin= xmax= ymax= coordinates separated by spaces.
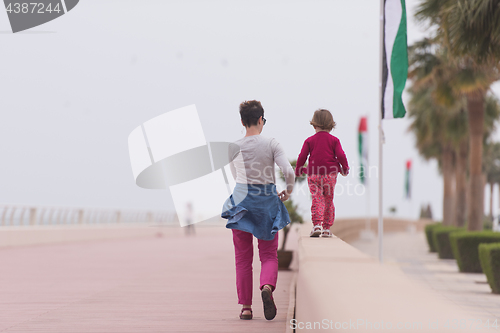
xmin=455 ymin=141 xmax=468 ymax=227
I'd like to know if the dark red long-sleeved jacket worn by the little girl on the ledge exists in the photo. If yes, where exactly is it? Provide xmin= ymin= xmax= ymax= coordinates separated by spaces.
xmin=295 ymin=131 xmax=349 ymax=177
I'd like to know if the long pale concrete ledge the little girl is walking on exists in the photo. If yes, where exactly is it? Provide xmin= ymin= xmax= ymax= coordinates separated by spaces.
xmin=294 ymin=225 xmax=482 ymax=332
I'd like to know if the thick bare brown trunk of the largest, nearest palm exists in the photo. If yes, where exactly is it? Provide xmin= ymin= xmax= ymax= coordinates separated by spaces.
xmin=467 ymin=93 xmax=484 ymax=231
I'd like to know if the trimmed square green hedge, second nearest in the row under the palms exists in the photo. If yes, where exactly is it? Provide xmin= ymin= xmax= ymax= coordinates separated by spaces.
xmin=450 ymin=231 xmax=500 ymax=273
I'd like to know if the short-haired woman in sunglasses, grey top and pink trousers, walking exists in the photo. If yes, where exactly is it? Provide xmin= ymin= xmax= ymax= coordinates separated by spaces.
xmin=221 ymin=101 xmax=295 ymax=320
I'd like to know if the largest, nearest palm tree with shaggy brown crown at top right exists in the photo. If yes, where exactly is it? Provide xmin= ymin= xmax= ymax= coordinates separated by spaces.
xmin=416 ymin=0 xmax=500 ymax=230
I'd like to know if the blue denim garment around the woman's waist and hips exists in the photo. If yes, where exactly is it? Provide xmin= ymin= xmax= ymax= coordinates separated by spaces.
xmin=221 ymin=183 xmax=290 ymax=240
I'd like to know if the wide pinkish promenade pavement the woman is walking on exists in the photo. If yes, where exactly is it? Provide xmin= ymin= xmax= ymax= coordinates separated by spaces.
xmin=0 ymin=226 xmax=293 ymax=333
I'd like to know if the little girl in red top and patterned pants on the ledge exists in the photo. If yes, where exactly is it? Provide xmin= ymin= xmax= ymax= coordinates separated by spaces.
xmin=295 ymin=109 xmax=349 ymax=237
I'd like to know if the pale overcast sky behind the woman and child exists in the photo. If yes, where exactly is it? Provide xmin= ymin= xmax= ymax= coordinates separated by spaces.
xmin=0 ymin=0 xmax=498 ymax=218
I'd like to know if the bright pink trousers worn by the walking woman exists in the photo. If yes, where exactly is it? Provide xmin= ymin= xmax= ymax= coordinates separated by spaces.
xmin=231 ymin=229 xmax=278 ymax=305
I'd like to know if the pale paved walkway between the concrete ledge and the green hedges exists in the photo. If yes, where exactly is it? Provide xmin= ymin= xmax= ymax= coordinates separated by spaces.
xmin=350 ymin=232 xmax=500 ymax=320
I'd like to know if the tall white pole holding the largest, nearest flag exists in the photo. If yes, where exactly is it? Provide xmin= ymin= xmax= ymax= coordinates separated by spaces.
xmin=377 ymin=0 xmax=385 ymax=263
